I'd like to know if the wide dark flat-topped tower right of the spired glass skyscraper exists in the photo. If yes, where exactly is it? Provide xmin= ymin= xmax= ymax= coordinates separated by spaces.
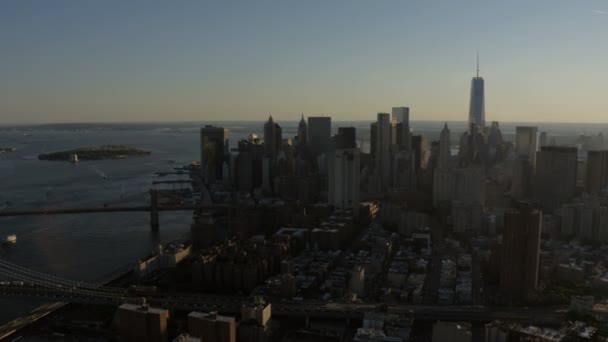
xmin=534 ymin=146 xmax=578 ymax=212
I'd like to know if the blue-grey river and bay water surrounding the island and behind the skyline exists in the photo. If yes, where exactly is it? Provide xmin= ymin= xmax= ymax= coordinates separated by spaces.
xmin=0 ymin=121 xmax=608 ymax=322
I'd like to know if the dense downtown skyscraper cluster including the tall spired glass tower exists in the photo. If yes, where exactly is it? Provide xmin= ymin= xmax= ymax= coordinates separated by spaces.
xmin=201 ymin=58 xmax=608 ymax=304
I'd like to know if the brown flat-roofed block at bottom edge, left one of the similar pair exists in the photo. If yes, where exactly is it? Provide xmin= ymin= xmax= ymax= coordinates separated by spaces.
xmin=118 ymin=303 xmax=169 ymax=342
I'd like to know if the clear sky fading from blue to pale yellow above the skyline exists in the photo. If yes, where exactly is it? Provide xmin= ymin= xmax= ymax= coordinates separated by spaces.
xmin=0 ymin=0 xmax=608 ymax=123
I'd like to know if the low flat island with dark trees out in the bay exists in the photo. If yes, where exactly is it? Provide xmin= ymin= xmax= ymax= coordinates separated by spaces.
xmin=38 ymin=145 xmax=150 ymax=161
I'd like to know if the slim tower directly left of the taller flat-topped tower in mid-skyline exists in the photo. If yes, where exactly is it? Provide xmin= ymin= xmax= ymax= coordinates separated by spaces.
xmin=374 ymin=113 xmax=391 ymax=192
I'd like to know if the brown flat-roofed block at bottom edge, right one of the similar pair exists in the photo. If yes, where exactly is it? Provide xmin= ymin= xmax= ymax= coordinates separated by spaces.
xmin=188 ymin=312 xmax=236 ymax=342
